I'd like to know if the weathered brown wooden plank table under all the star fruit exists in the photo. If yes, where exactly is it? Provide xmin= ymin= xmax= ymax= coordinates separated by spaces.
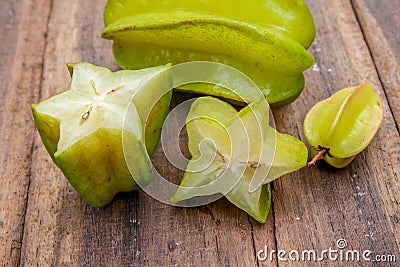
xmin=0 ymin=0 xmax=400 ymax=266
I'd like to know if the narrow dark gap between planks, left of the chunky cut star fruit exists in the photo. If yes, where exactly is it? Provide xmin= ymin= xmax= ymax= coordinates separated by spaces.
xmin=17 ymin=0 xmax=54 ymax=266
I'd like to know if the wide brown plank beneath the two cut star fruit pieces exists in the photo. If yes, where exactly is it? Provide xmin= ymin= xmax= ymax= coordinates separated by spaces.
xmin=21 ymin=0 xmax=274 ymax=266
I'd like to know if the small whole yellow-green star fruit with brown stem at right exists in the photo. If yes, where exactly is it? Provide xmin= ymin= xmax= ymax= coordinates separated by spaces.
xmin=304 ymin=83 xmax=383 ymax=168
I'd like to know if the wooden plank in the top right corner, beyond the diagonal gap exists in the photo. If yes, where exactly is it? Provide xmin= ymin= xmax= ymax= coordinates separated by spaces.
xmin=353 ymin=0 xmax=400 ymax=253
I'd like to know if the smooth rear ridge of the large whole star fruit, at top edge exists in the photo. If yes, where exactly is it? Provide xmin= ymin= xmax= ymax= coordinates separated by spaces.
xmin=104 ymin=0 xmax=315 ymax=48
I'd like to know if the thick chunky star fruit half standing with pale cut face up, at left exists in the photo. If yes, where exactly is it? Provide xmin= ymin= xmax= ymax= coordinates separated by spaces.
xmin=32 ymin=63 xmax=171 ymax=207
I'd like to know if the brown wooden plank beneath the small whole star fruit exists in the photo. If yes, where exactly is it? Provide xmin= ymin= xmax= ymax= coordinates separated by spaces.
xmin=255 ymin=0 xmax=400 ymax=266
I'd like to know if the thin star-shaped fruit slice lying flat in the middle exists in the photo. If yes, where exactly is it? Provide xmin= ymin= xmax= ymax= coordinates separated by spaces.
xmin=171 ymin=97 xmax=308 ymax=223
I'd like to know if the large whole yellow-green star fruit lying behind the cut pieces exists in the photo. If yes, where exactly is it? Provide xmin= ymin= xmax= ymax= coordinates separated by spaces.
xmin=103 ymin=1 xmax=315 ymax=106
